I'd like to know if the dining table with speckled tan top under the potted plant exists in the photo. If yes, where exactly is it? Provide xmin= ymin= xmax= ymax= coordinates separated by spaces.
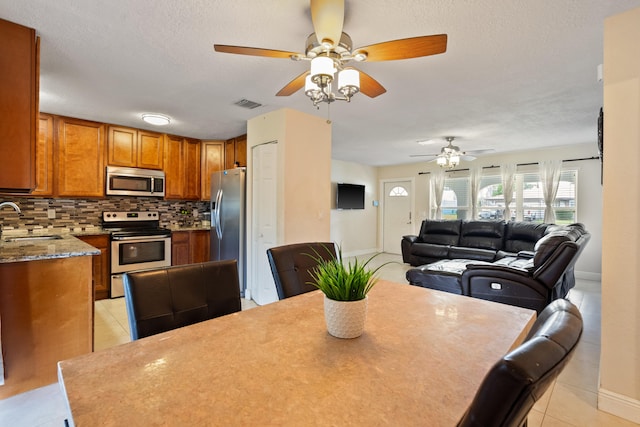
xmin=58 ymin=280 xmax=536 ymax=426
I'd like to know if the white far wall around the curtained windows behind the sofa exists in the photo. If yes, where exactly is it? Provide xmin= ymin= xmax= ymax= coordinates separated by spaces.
xmin=380 ymin=144 xmax=602 ymax=280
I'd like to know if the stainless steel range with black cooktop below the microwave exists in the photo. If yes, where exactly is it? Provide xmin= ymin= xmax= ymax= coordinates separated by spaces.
xmin=102 ymin=211 xmax=171 ymax=298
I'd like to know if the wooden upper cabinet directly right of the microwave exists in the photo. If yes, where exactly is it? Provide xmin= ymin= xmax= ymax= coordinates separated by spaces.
xmin=164 ymin=135 xmax=200 ymax=200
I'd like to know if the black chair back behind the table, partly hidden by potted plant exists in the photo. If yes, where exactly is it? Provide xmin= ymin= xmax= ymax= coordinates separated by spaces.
xmin=267 ymin=242 xmax=336 ymax=299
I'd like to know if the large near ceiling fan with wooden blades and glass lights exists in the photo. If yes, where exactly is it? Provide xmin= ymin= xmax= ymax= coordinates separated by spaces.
xmin=213 ymin=0 xmax=447 ymax=106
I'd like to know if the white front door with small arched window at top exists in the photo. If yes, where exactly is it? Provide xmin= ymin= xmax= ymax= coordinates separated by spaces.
xmin=382 ymin=181 xmax=413 ymax=254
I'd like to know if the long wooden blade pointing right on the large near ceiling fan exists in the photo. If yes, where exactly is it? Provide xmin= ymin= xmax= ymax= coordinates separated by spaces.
xmin=353 ymin=34 xmax=447 ymax=61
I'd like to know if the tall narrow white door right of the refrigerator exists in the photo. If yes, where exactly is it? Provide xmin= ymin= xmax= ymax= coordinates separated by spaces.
xmin=250 ymin=143 xmax=278 ymax=305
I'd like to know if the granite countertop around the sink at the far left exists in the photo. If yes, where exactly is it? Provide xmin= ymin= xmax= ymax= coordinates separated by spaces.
xmin=0 ymin=233 xmax=100 ymax=263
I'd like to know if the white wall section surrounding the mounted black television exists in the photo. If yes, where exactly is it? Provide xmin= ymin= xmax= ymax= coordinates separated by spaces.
xmin=331 ymin=160 xmax=379 ymax=256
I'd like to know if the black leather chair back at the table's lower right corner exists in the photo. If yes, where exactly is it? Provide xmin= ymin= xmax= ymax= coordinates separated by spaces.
xmin=458 ymin=299 xmax=582 ymax=427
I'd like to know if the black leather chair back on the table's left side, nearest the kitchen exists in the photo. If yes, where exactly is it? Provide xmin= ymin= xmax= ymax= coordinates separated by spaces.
xmin=124 ymin=260 xmax=241 ymax=340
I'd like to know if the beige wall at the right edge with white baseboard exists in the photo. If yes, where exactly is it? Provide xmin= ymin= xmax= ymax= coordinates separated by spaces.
xmin=598 ymin=8 xmax=640 ymax=423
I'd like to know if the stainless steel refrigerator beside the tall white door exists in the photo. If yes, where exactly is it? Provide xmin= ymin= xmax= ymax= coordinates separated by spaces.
xmin=211 ymin=167 xmax=247 ymax=296
